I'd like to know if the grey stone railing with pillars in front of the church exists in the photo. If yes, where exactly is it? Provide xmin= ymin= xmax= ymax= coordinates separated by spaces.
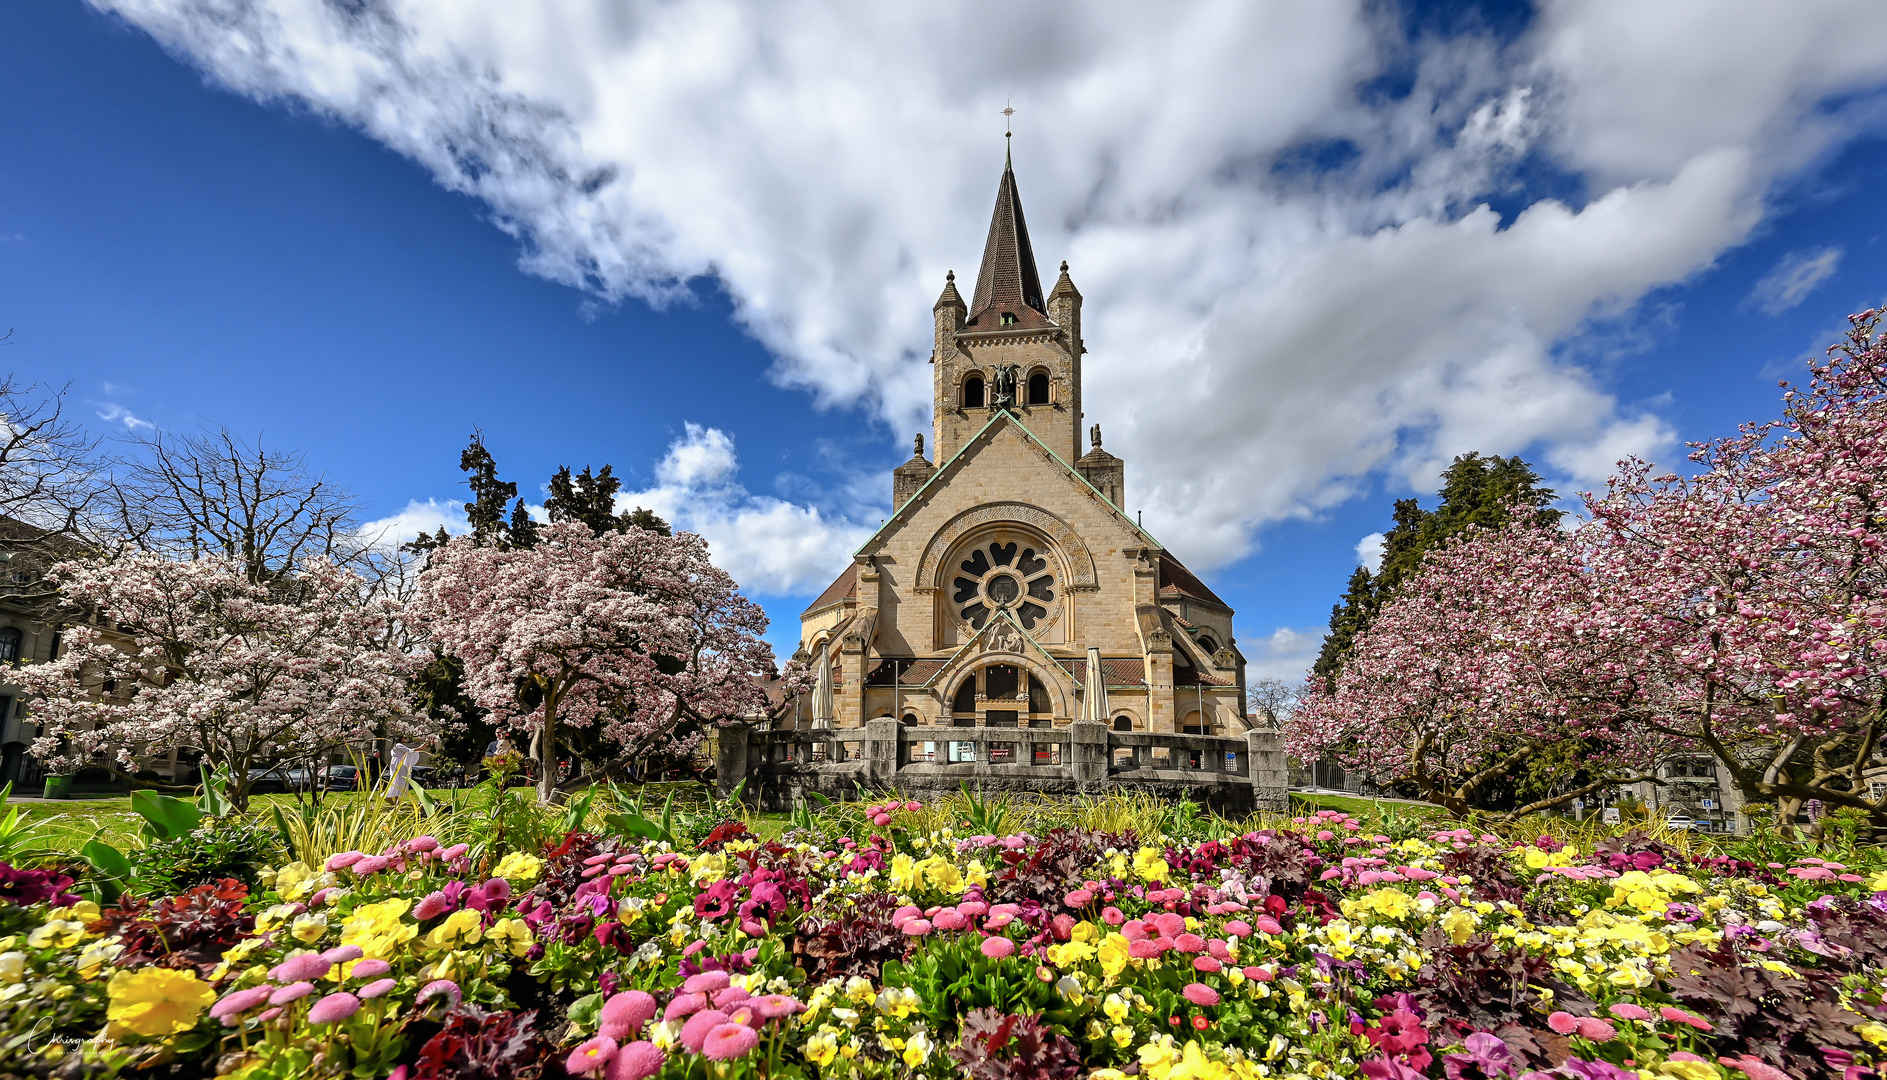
xmin=715 ymin=717 xmax=1287 ymax=814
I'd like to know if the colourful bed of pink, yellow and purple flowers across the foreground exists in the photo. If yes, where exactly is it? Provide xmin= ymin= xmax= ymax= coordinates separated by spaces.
xmin=0 ymin=802 xmax=1887 ymax=1080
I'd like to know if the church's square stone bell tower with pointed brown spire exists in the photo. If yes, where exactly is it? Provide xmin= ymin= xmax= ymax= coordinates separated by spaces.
xmin=930 ymin=147 xmax=1087 ymax=464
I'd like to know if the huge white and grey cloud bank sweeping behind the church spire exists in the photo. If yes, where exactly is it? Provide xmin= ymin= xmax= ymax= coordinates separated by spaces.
xmin=92 ymin=0 xmax=1887 ymax=570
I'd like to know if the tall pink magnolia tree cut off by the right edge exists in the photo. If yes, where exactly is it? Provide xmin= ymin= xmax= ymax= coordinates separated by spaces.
xmin=1589 ymin=312 xmax=1887 ymax=829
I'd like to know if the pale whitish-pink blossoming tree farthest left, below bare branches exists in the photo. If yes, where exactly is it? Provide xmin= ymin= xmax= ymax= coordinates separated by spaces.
xmin=19 ymin=553 xmax=413 ymax=808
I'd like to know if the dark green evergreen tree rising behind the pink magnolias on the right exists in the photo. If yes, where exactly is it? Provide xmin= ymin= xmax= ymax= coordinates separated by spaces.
xmin=1311 ymin=453 xmax=1561 ymax=683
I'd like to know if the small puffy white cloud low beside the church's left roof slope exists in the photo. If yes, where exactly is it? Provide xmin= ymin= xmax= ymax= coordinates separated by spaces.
xmin=615 ymin=423 xmax=870 ymax=595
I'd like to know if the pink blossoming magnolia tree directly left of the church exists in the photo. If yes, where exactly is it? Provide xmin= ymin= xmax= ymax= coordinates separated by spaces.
xmin=411 ymin=523 xmax=806 ymax=802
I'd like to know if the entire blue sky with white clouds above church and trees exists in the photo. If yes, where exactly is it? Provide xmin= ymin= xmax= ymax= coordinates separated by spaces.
xmin=0 ymin=0 xmax=1887 ymax=678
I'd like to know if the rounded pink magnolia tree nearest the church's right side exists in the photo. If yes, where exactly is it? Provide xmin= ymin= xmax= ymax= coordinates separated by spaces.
xmin=1287 ymin=514 xmax=1674 ymax=816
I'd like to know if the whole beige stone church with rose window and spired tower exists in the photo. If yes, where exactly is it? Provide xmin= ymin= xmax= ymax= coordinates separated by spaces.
xmin=794 ymin=150 xmax=1249 ymax=736
